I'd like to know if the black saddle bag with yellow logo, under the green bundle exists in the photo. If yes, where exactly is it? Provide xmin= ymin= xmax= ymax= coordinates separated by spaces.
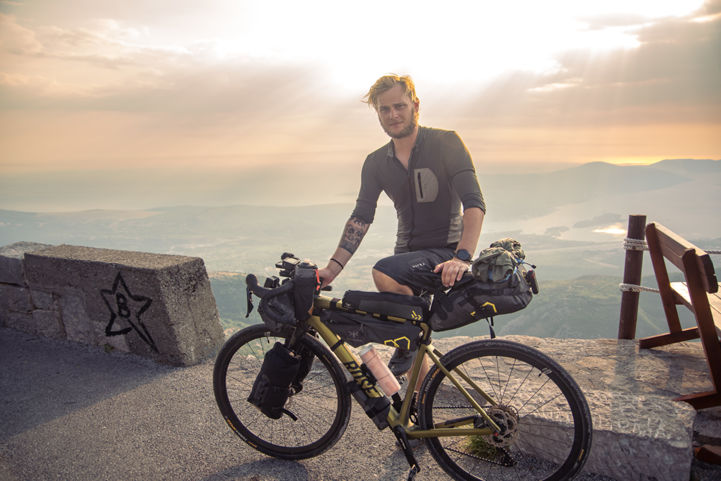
xmin=428 ymin=266 xmax=533 ymax=331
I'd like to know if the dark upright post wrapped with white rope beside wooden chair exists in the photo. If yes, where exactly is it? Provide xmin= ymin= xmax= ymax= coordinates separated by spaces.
xmin=618 ymin=215 xmax=646 ymax=339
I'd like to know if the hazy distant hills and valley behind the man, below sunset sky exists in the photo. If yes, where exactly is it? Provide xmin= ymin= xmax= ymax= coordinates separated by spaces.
xmin=0 ymin=159 xmax=721 ymax=289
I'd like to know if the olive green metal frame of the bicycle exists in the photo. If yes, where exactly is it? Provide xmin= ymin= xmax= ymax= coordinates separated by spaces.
xmin=306 ymin=296 xmax=500 ymax=439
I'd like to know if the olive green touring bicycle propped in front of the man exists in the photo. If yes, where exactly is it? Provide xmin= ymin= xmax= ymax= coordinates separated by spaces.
xmin=213 ymin=254 xmax=592 ymax=480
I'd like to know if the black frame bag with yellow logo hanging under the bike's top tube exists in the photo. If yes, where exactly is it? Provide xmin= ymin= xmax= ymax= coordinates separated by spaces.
xmin=320 ymin=310 xmax=421 ymax=351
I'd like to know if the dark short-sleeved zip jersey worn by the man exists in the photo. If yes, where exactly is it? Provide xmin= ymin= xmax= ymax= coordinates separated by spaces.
xmin=352 ymin=127 xmax=486 ymax=254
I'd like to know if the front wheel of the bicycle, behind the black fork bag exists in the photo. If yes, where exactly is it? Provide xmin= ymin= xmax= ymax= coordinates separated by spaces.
xmin=213 ymin=324 xmax=351 ymax=459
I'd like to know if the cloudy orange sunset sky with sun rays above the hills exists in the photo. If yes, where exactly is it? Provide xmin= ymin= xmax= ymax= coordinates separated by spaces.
xmin=0 ymin=0 xmax=721 ymax=210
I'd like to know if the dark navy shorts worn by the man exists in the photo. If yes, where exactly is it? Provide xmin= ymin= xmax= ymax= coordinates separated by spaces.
xmin=373 ymin=247 xmax=455 ymax=295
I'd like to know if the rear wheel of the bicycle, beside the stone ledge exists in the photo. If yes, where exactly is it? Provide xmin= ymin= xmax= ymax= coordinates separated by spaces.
xmin=419 ymin=340 xmax=592 ymax=481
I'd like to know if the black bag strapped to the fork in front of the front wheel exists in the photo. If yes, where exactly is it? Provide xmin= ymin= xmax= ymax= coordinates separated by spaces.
xmin=248 ymin=342 xmax=300 ymax=419
